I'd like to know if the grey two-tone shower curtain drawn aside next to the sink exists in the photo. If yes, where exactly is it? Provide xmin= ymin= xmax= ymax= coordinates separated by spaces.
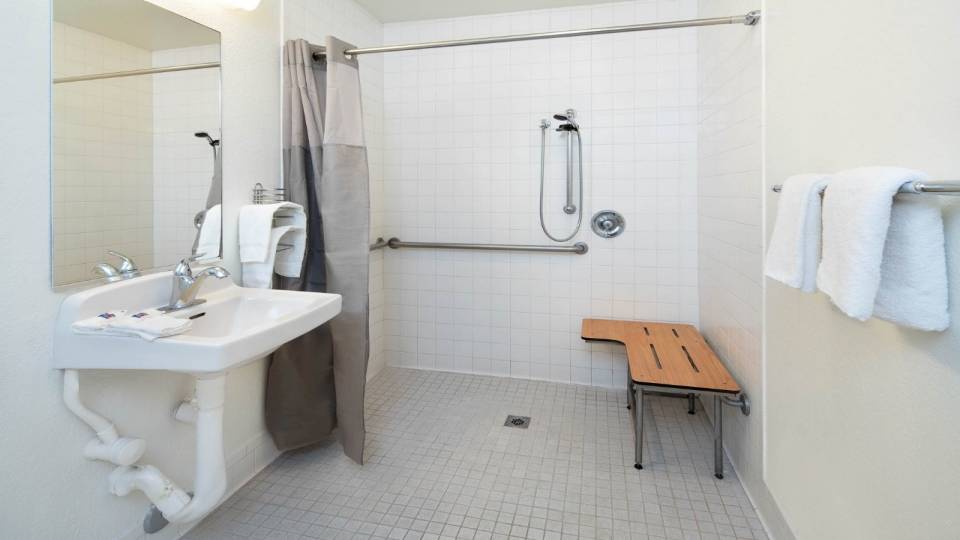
xmin=266 ymin=37 xmax=370 ymax=463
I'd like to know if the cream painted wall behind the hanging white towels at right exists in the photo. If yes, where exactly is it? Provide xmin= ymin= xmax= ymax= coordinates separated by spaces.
xmin=763 ymin=0 xmax=960 ymax=540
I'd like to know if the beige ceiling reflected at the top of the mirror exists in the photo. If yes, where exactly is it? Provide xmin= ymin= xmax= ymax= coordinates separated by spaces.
xmin=53 ymin=0 xmax=220 ymax=51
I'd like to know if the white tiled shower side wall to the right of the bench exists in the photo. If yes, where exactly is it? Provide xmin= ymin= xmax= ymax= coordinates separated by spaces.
xmin=698 ymin=0 xmax=766 ymax=516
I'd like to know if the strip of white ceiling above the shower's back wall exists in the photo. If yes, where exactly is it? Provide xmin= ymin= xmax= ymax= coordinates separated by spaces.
xmin=357 ymin=0 xmax=611 ymax=23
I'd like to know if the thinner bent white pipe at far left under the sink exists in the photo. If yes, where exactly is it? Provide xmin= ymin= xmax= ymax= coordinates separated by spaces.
xmin=63 ymin=369 xmax=147 ymax=465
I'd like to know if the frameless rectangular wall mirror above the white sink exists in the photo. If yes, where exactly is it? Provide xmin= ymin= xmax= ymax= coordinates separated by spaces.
xmin=51 ymin=0 xmax=222 ymax=286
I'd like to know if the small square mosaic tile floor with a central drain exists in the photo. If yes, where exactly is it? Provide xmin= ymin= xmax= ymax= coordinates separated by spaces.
xmin=186 ymin=368 xmax=766 ymax=540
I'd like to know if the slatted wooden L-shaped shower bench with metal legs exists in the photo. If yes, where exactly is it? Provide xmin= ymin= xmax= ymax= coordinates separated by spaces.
xmin=580 ymin=319 xmax=750 ymax=478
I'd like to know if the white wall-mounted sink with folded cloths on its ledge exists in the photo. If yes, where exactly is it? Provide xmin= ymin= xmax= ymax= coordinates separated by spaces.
xmin=53 ymin=272 xmax=340 ymax=374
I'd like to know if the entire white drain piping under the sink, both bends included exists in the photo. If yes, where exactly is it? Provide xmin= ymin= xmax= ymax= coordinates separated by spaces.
xmin=63 ymin=369 xmax=227 ymax=532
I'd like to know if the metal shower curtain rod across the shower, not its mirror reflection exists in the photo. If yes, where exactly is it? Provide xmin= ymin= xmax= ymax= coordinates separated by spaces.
xmin=313 ymin=10 xmax=760 ymax=60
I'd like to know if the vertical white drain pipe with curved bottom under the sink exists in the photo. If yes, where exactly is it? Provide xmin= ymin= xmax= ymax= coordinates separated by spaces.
xmin=164 ymin=372 xmax=227 ymax=523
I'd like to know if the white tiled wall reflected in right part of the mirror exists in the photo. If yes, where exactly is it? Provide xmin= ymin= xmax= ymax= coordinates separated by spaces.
xmin=153 ymin=45 xmax=222 ymax=266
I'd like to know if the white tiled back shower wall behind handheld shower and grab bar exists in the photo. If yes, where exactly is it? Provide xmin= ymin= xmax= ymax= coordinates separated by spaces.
xmin=383 ymin=0 xmax=698 ymax=386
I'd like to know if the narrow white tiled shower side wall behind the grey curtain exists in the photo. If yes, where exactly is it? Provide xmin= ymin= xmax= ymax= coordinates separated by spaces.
xmin=283 ymin=0 xmax=386 ymax=378
